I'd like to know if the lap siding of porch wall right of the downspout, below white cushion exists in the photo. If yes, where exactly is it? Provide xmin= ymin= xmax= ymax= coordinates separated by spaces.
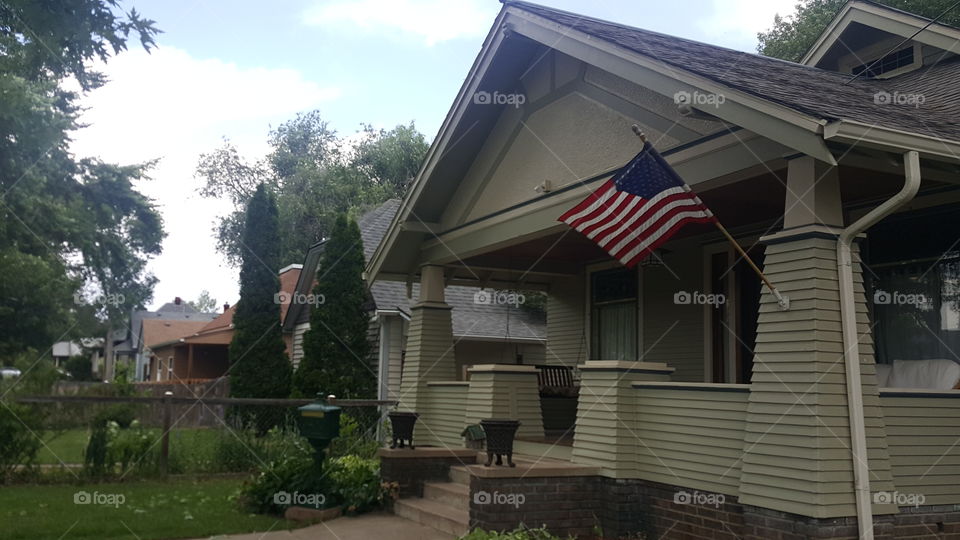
xmin=880 ymin=396 xmax=960 ymax=505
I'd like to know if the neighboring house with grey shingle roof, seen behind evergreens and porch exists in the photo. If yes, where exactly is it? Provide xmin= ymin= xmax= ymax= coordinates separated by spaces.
xmin=284 ymin=199 xmax=546 ymax=400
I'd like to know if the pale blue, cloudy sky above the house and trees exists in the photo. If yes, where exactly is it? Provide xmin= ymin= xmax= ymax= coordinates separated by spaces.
xmin=72 ymin=0 xmax=796 ymax=309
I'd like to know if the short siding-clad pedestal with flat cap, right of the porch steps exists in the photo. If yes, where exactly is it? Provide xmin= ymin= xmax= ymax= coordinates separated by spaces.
xmin=573 ymin=360 xmax=674 ymax=478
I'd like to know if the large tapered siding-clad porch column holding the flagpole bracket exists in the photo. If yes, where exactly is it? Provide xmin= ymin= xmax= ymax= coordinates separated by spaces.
xmin=739 ymin=157 xmax=896 ymax=531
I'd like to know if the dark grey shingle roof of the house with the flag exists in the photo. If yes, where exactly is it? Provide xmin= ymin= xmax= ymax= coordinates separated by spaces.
xmin=505 ymin=0 xmax=960 ymax=140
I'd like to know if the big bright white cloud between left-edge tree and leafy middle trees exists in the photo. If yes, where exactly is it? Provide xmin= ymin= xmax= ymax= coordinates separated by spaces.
xmin=71 ymin=47 xmax=340 ymax=306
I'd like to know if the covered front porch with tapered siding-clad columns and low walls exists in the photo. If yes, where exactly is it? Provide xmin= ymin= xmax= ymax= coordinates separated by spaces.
xmin=372 ymin=151 xmax=960 ymax=535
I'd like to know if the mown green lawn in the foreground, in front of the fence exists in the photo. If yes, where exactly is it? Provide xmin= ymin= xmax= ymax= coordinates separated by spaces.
xmin=0 ymin=480 xmax=308 ymax=540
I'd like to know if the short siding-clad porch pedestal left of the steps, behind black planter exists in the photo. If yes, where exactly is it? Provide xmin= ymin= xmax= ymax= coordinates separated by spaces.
xmin=467 ymin=364 xmax=544 ymax=439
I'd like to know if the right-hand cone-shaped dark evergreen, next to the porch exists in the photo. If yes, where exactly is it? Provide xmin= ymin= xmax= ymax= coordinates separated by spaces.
xmin=294 ymin=214 xmax=376 ymax=398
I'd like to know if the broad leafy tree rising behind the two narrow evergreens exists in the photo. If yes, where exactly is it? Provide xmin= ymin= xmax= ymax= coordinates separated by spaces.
xmin=196 ymin=111 xmax=428 ymax=264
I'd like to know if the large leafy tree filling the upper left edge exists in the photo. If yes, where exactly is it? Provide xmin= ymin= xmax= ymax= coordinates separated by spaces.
xmin=0 ymin=0 xmax=163 ymax=356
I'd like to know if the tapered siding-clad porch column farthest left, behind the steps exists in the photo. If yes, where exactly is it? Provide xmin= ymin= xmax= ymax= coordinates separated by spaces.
xmin=398 ymin=266 xmax=457 ymax=411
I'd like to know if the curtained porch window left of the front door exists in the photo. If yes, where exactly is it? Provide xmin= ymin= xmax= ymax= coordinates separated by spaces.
xmin=590 ymin=268 xmax=637 ymax=360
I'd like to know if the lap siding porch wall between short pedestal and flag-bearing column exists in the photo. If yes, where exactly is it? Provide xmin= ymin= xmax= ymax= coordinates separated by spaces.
xmin=634 ymin=388 xmax=748 ymax=495
